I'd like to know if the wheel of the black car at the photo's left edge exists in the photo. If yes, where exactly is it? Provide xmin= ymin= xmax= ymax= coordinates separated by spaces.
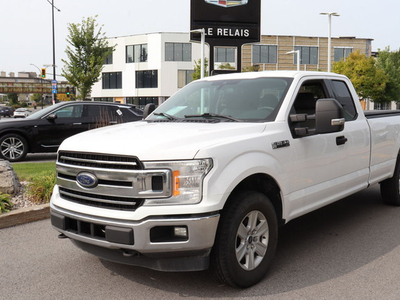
xmin=0 ymin=133 xmax=28 ymax=162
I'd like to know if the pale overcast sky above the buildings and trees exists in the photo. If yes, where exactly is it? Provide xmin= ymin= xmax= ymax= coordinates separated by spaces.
xmin=0 ymin=0 xmax=400 ymax=76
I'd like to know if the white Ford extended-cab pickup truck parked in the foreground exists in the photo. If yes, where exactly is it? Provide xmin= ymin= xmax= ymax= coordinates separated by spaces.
xmin=51 ymin=71 xmax=400 ymax=287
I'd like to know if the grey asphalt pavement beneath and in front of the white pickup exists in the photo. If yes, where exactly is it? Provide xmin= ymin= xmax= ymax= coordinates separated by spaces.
xmin=0 ymin=186 xmax=400 ymax=300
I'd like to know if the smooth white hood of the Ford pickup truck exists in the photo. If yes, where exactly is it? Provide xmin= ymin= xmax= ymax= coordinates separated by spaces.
xmin=59 ymin=121 xmax=266 ymax=161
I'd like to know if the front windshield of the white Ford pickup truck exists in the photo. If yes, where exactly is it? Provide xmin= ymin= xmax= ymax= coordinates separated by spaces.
xmin=146 ymin=77 xmax=292 ymax=122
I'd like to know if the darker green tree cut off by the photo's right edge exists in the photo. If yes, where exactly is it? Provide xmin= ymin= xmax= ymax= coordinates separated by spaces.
xmin=377 ymin=47 xmax=400 ymax=102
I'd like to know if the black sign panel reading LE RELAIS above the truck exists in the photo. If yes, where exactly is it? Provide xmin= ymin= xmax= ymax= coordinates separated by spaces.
xmin=190 ymin=0 xmax=261 ymax=46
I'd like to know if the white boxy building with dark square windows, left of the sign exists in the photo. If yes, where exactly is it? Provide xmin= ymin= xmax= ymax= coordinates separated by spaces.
xmin=92 ymin=32 xmax=205 ymax=108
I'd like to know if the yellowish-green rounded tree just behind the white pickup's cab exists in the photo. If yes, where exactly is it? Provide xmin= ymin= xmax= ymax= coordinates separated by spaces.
xmin=332 ymin=51 xmax=388 ymax=102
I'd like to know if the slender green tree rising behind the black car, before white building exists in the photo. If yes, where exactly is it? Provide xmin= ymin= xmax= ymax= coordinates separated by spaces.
xmin=62 ymin=16 xmax=115 ymax=99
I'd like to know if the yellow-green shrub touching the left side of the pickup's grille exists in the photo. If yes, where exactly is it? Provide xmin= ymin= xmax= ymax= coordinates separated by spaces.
xmin=26 ymin=171 xmax=56 ymax=204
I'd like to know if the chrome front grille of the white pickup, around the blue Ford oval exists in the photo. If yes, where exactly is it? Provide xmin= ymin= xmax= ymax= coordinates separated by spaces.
xmin=56 ymin=151 xmax=172 ymax=211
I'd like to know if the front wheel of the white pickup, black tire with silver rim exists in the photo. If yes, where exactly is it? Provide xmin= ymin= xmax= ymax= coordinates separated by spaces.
xmin=210 ymin=191 xmax=278 ymax=288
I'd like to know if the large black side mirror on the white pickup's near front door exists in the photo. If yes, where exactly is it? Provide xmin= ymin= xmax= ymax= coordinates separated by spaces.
xmin=315 ymin=98 xmax=345 ymax=134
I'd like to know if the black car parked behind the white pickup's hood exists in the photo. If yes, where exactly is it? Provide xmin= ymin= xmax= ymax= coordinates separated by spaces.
xmin=0 ymin=101 xmax=143 ymax=162
